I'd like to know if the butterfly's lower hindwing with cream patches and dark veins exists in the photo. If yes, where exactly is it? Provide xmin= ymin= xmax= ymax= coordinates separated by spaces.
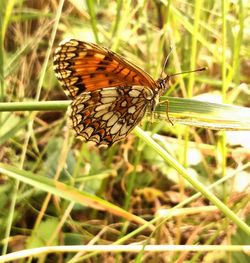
xmin=70 ymin=86 xmax=153 ymax=145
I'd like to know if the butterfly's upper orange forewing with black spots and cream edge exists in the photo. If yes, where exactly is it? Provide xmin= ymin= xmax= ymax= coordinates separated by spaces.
xmin=54 ymin=39 xmax=157 ymax=98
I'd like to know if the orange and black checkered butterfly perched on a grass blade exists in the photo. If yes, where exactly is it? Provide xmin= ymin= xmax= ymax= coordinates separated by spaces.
xmin=54 ymin=39 xmax=169 ymax=146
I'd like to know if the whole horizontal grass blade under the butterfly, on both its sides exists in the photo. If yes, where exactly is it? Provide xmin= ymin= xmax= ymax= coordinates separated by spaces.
xmin=0 ymin=97 xmax=250 ymax=130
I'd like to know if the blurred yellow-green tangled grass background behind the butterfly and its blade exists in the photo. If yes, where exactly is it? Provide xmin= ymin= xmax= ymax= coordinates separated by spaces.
xmin=0 ymin=0 xmax=250 ymax=262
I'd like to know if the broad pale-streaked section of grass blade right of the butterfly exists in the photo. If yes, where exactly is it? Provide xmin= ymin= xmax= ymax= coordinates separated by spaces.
xmin=155 ymin=97 xmax=250 ymax=130
